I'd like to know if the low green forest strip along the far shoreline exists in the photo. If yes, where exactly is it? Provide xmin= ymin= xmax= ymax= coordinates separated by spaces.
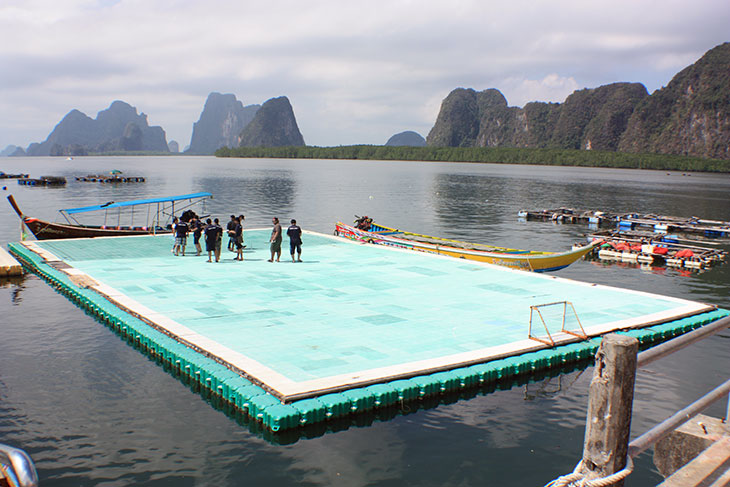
xmin=215 ymin=145 xmax=730 ymax=173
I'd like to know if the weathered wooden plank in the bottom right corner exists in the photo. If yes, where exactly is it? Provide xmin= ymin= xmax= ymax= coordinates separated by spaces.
xmin=658 ymin=436 xmax=730 ymax=487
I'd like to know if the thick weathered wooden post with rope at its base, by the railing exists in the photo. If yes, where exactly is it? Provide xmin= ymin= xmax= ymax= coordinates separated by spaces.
xmin=580 ymin=333 xmax=639 ymax=487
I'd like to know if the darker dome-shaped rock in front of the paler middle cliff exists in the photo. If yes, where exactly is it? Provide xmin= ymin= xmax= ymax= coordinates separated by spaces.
xmin=240 ymin=96 xmax=304 ymax=147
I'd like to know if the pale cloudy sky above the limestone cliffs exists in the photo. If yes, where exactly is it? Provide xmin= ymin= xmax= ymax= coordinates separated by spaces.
xmin=0 ymin=0 xmax=730 ymax=149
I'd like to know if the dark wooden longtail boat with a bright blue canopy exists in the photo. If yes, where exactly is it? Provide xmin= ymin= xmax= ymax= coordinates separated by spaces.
xmin=8 ymin=193 xmax=213 ymax=240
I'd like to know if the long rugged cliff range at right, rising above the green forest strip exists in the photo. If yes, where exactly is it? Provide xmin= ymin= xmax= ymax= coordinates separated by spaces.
xmin=426 ymin=43 xmax=730 ymax=159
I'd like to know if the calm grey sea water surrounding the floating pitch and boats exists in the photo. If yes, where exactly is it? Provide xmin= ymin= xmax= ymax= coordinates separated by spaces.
xmin=0 ymin=157 xmax=730 ymax=487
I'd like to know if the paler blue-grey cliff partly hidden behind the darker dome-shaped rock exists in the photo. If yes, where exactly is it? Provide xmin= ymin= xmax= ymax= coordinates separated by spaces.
xmin=185 ymin=93 xmax=261 ymax=155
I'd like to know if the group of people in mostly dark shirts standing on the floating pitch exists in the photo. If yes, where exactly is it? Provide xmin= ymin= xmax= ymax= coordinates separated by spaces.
xmin=172 ymin=215 xmax=302 ymax=262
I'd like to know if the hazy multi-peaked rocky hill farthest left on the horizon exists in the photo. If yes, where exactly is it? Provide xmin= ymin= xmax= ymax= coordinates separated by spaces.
xmin=26 ymin=100 xmax=168 ymax=156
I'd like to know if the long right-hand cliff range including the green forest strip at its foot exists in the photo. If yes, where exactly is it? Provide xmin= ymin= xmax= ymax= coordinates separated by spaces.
xmin=216 ymin=43 xmax=730 ymax=172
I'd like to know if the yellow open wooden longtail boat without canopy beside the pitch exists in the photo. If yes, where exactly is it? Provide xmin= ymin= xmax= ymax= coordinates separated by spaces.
xmin=335 ymin=222 xmax=601 ymax=272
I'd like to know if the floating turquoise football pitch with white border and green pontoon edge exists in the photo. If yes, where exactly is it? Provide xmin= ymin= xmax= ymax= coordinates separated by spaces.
xmin=9 ymin=229 xmax=730 ymax=431
